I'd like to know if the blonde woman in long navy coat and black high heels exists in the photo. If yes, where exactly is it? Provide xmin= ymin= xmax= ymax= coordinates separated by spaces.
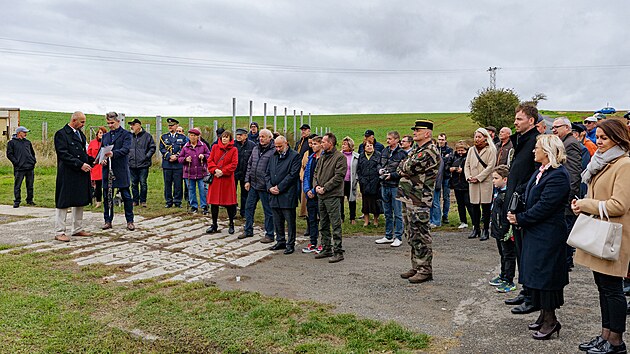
xmin=508 ymin=135 xmax=571 ymax=339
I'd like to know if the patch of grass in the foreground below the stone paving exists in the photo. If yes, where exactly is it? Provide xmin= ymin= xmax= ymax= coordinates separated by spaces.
xmin=0 ymin=252 xmax=429 ymax=353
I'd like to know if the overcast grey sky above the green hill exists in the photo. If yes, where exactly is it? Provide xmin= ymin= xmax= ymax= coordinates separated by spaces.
xmin=0 ymin=0 xmax=630 ymax=116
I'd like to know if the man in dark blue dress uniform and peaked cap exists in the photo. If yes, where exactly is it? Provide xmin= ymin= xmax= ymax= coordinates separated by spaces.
xmin=160 ymin=118 xmax=187 ymax=208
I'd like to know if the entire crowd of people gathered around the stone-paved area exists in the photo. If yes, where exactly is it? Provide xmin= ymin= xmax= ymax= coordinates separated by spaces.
xmin=7 ymin=104 xmax=630 ymax=353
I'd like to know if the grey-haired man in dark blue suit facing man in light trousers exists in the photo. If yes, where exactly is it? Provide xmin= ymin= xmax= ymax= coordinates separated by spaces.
xmin=100 ymin=112 xmax=136 ymax=231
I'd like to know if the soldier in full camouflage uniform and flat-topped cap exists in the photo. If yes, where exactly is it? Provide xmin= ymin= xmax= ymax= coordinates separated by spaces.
xmin=397 ymin=119 xmax=441 ymax=284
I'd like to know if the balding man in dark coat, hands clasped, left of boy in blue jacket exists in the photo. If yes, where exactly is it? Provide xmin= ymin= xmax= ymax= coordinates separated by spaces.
xmin=265 ymin=135 xmax=302 ymax=254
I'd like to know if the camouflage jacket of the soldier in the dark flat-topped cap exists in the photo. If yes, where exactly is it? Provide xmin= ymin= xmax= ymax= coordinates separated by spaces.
xmin=397 ymin=141 xmax=442 ymax=208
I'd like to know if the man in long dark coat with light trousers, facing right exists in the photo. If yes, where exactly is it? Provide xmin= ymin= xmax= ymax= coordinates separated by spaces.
xmin=55 ymin=112 xmax=93 ymax=242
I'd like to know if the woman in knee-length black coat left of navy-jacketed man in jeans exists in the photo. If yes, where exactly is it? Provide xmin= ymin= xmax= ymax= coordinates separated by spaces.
xmin=357 ymin=138 xmax=382 ymax=226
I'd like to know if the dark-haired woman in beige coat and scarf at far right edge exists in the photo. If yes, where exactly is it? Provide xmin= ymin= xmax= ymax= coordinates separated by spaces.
xmin=571 ymin=119 xmax=630 ymax=353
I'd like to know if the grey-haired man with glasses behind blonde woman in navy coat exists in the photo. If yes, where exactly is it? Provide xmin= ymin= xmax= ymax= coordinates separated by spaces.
xmin=551 ymin=117 xmax=583 ymax=268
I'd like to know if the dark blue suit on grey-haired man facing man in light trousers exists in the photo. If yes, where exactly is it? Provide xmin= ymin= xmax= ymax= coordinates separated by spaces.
xmin=102 ymin=127 xmax=133 ymax=223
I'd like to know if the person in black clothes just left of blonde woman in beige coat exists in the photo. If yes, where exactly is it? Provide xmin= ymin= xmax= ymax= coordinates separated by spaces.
xmin=448 ymin=140 xmax=470 ymax=229
